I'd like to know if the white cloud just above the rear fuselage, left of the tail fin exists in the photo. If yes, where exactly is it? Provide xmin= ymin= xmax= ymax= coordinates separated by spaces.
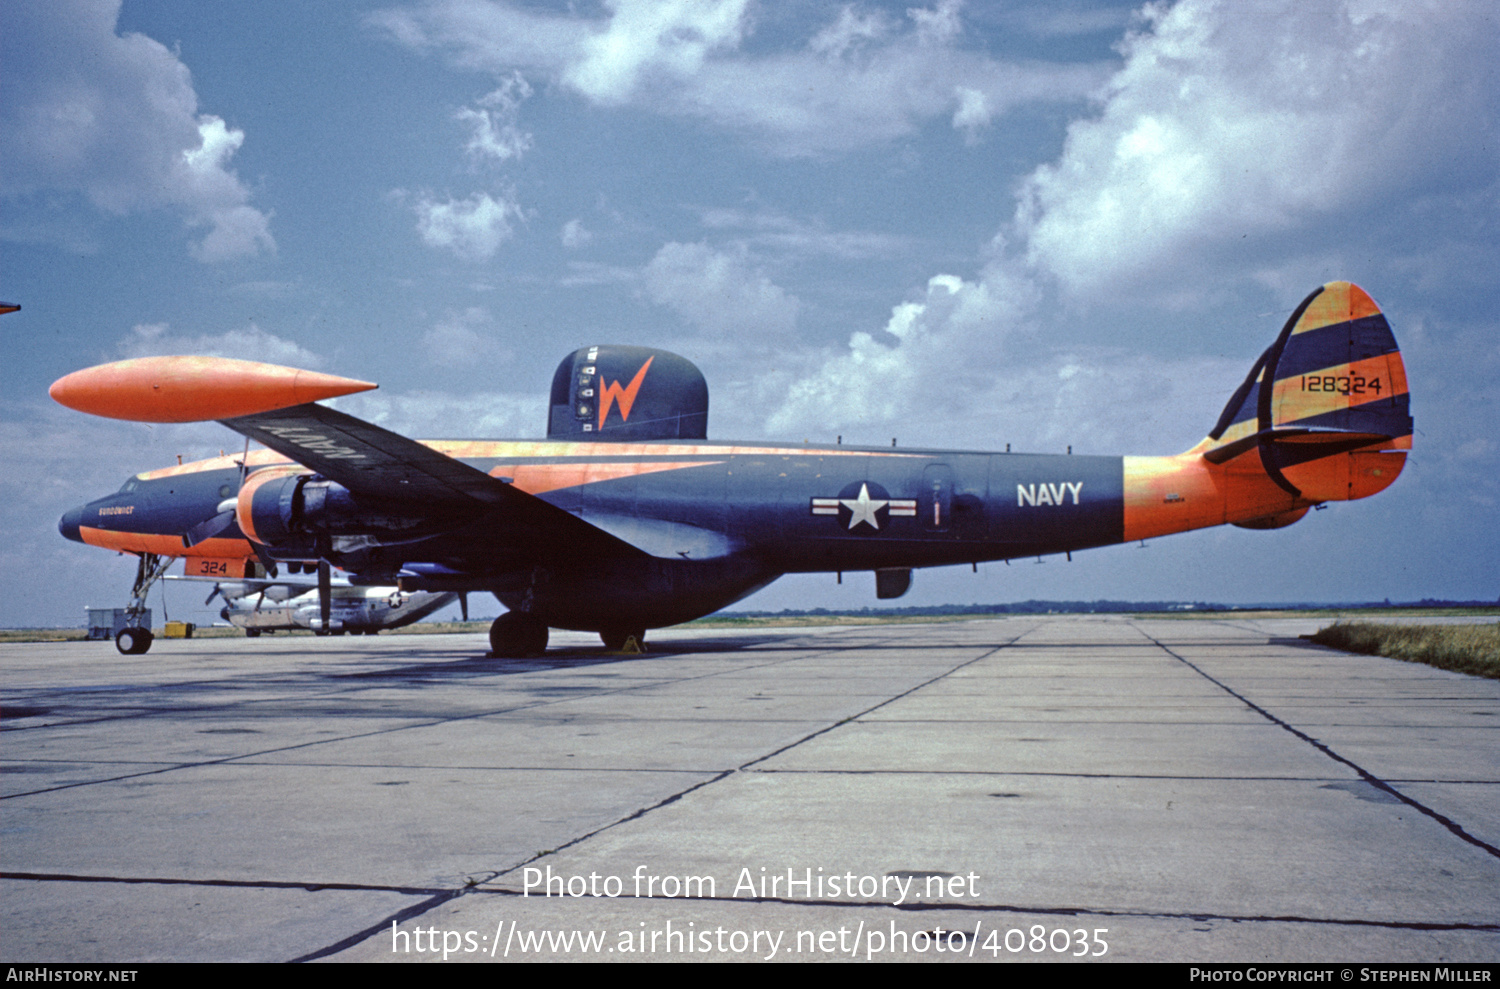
xmin=767 ymin=261 xmax=1248 ymax=453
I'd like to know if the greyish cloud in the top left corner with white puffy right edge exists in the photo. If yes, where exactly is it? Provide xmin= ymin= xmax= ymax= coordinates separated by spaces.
xmin=0 ymin=0 xmax=276 ymax=261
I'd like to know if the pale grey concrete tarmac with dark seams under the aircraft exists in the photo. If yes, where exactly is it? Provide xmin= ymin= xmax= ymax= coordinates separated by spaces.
xmin=0 ymin=615 xmax=1500 ymax=963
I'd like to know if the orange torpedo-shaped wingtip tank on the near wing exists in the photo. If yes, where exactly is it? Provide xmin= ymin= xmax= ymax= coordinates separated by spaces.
xmin=48 ymin=357 xmax=378 ymax=422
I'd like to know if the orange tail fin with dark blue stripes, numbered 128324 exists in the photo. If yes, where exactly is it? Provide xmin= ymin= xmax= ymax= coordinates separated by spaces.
xmin=1194 ymin=282 xmax=1412 ymax=501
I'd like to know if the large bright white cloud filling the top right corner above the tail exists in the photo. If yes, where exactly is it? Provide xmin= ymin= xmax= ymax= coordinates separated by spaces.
xmin=1017 ymin=0 xmax=1500 ymax=291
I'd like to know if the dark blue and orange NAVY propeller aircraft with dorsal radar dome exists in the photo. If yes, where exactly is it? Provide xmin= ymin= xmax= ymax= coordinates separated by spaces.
xmin=51 ymin=282 xmax=1412 ymax=656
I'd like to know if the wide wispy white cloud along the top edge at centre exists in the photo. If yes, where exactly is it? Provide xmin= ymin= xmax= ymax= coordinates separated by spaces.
xmin=372 ymin=0 xmax=1106 ymax=156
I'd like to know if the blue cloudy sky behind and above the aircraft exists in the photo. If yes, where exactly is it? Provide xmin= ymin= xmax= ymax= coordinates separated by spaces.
xmin=0 ymin=0 xmax=1500 ymax=626
